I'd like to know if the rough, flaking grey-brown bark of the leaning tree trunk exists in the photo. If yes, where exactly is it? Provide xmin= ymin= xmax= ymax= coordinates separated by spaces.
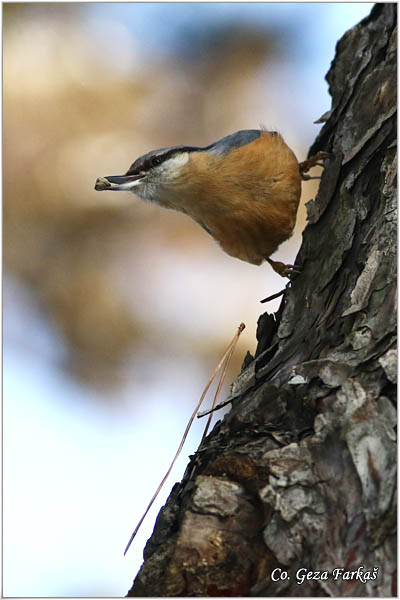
xmin=128 ymin=4 xmax=397 ymax=596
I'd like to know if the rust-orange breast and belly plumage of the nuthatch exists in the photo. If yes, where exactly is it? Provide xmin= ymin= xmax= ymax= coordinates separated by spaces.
xmin=186 ymin=132 xmax=301 ymax=264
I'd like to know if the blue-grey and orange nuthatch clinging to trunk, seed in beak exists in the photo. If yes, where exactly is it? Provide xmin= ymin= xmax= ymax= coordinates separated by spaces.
xmin=95 ymin=129 xmax=326 ymax=277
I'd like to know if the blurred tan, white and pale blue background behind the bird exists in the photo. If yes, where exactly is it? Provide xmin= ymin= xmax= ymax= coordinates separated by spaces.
xmin=3 ymin=3 xmax=372 ymax=597
